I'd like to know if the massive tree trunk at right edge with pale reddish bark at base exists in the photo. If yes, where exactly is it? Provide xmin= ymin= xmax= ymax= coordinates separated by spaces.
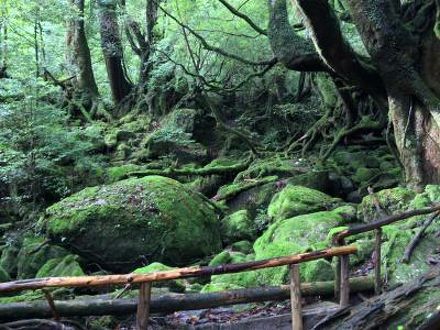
xmin=347 ymin=0 xmax=440 ymax=187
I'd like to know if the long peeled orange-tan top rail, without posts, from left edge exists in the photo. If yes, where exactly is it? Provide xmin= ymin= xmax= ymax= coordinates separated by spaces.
xmin=0 ymin=245 xmax=357 ymax=293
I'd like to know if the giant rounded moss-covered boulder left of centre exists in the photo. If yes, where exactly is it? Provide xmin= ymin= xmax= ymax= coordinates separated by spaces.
xmin=42 ymin=176 xmax=221 ymax=271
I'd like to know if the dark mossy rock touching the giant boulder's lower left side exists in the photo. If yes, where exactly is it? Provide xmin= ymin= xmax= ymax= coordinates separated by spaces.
xmin=15 ymin=237 xmax=68 ymax=279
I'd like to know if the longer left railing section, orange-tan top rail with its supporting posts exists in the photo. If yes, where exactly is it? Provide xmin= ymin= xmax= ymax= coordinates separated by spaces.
xmin=0 ymin=245 xmax=357 ymax=330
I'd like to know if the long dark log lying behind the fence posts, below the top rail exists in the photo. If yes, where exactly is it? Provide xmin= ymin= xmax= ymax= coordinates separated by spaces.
xmin=0 ymin=276 xmax=374 ymax=322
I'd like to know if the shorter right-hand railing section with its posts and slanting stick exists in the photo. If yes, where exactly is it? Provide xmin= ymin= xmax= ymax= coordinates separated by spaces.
xmin=333 ymin=204 xmax=440 ymax=300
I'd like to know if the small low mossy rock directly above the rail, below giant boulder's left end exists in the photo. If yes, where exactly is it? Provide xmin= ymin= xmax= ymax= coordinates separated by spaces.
xmin=35 ymin=254 xmax=85 ymax=277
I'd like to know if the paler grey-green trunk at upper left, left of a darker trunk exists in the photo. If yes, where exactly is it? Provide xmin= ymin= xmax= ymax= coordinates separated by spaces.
xmin=66 ymin=0 xmax=99 ymax=104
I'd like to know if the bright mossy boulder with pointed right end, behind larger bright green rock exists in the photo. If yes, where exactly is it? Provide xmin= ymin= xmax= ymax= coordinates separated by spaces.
xmin=267 ymin=185 xmax=341 ymax=221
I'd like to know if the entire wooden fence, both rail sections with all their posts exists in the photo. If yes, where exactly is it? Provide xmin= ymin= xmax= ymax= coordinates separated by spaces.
xmin=0 ymin=205 xmax=440 ymax=330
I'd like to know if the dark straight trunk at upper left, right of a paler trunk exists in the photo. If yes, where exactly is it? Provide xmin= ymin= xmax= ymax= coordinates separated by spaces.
xmin=98 ymin=0 xmax=132 ymax=104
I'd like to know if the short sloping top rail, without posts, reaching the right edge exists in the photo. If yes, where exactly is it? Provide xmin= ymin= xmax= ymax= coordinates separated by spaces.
xmin=333 ymin=204 xmax=440 ymax=243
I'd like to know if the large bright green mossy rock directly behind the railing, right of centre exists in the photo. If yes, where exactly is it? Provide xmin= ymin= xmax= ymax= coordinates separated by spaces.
xmin=211 ymin=206 xmax=356 ymax=287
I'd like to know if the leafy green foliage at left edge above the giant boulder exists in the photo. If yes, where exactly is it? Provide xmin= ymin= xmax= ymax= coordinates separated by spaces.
xmin=0 ymin=79 xmax=102 ymax=220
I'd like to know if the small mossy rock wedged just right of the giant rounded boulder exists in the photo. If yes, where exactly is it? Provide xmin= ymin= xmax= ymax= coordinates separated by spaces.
xmin=222 ymin=210 xmax=257 ymax=243
